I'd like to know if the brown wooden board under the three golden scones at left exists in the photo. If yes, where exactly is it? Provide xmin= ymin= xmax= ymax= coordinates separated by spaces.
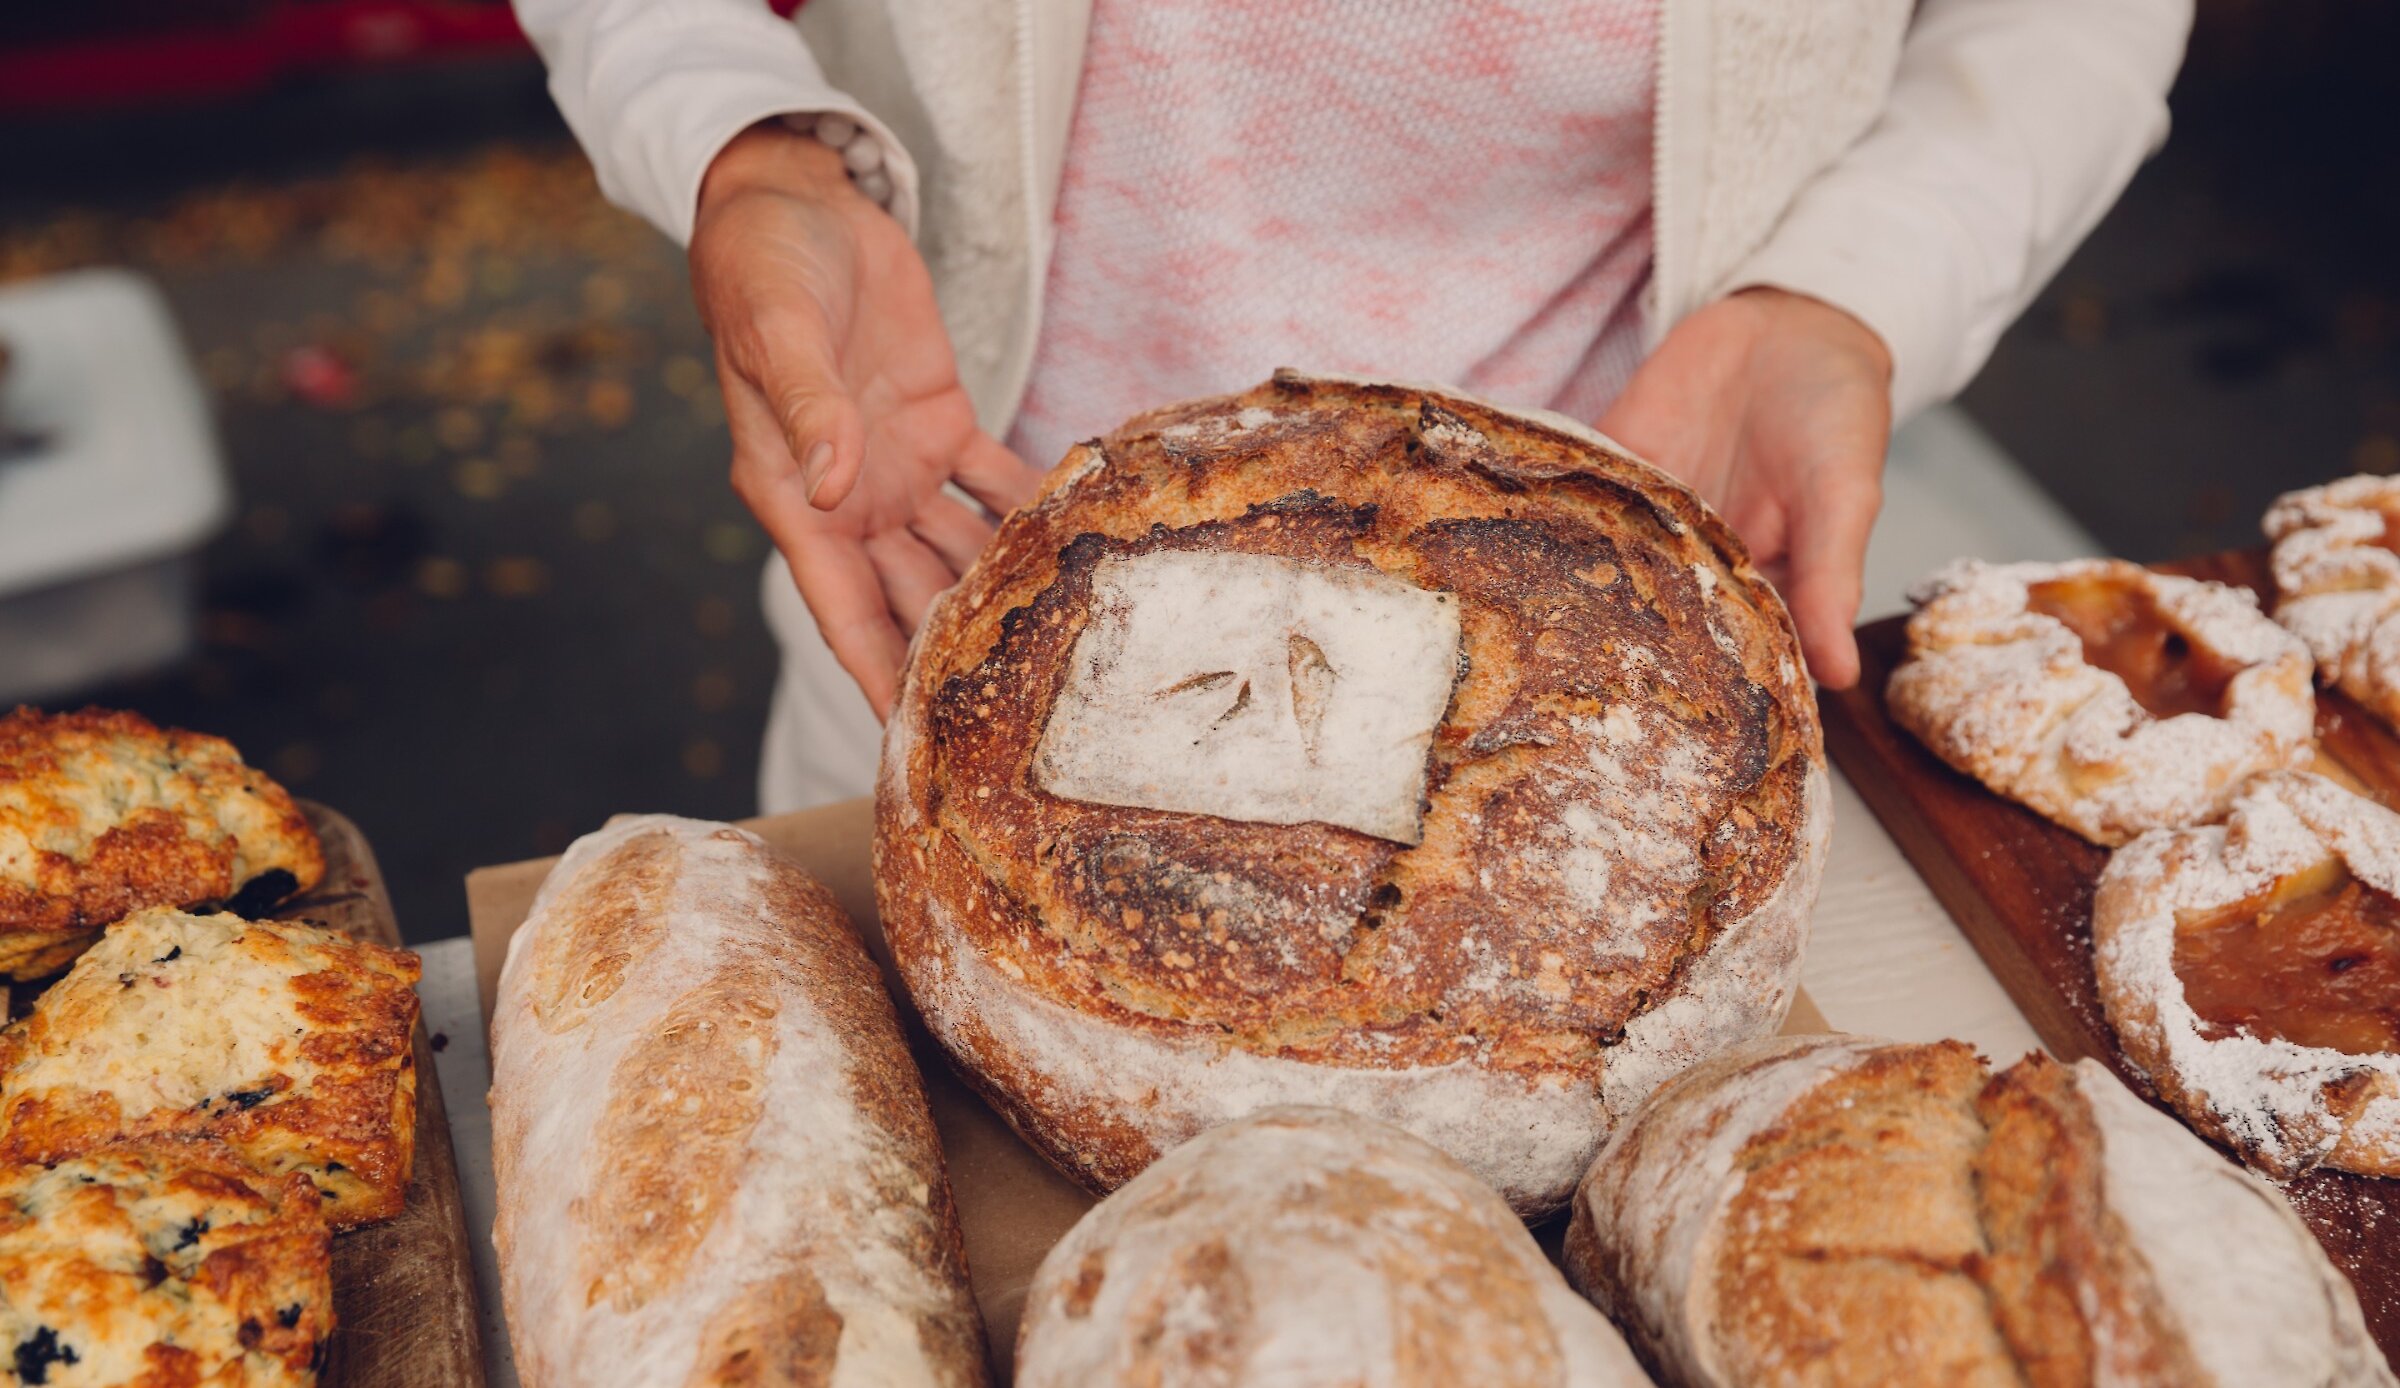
xmin=274 ymin=800 xmax=482 ymax=1388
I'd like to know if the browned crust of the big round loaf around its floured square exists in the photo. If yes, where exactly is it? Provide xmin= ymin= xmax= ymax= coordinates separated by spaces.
xmin=878 ymin=377 xmax=1824 ymax=1203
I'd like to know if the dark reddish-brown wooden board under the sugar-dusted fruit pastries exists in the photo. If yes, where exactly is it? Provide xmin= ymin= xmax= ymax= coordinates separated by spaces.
xmin=1819 ymin=550 xmax=2400 ymax=1364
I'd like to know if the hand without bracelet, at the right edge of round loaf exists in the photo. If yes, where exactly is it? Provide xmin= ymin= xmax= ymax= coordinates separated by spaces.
xmin=1601 ymin=288 xmax=1891 ymax=689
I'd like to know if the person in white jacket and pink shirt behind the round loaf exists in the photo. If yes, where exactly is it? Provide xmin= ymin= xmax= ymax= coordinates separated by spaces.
xmin=516 ymin=0 xmax=2191 ymax=812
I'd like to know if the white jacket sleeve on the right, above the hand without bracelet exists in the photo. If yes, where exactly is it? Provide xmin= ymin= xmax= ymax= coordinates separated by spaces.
xmin=1726 ymin=0 xmax=2191 ymax=415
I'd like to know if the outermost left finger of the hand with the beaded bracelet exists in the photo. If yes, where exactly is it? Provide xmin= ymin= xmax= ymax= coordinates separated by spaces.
xmin=725 ymin=369 xmax=907 ymax=718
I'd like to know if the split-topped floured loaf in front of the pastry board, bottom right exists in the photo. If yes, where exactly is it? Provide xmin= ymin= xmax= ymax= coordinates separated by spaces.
xmin=1565 ymin=1035 xmax=2393 ymax=1388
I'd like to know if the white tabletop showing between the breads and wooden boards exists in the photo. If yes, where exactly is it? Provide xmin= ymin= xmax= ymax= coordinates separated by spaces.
xmin=418 ymin=408 xmax=2100 ymax=1388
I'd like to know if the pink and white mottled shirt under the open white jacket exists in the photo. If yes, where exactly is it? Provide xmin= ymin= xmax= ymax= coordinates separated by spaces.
xmin=1010 ymin=0 xmax=1658 ymax=463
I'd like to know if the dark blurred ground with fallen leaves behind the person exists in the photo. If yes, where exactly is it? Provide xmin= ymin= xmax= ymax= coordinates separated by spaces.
xmin=0 ymin=0 xmax=2400 ymax=939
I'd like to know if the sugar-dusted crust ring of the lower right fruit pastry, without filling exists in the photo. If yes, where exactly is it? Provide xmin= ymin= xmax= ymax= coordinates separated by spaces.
xmin=2093 ymin=771 xmax=2400 ymax=1177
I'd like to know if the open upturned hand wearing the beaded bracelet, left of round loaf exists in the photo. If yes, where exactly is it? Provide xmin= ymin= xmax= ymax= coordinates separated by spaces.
xmin=691 ymin=125 xmax=1042 ymax=716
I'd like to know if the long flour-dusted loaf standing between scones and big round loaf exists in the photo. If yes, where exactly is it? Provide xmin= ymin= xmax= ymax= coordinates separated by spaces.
xmin=492 ymin=816 xmax=986 ymax=1388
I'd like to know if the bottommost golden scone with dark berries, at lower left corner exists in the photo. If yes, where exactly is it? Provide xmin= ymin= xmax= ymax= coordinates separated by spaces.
xmin=0 ymin=1141 xmax=334 ymax=1388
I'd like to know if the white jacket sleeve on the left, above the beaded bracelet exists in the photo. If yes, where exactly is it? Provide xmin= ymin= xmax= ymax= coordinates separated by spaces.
xmin=514 ymin=0 xmax=917 ymax=243
